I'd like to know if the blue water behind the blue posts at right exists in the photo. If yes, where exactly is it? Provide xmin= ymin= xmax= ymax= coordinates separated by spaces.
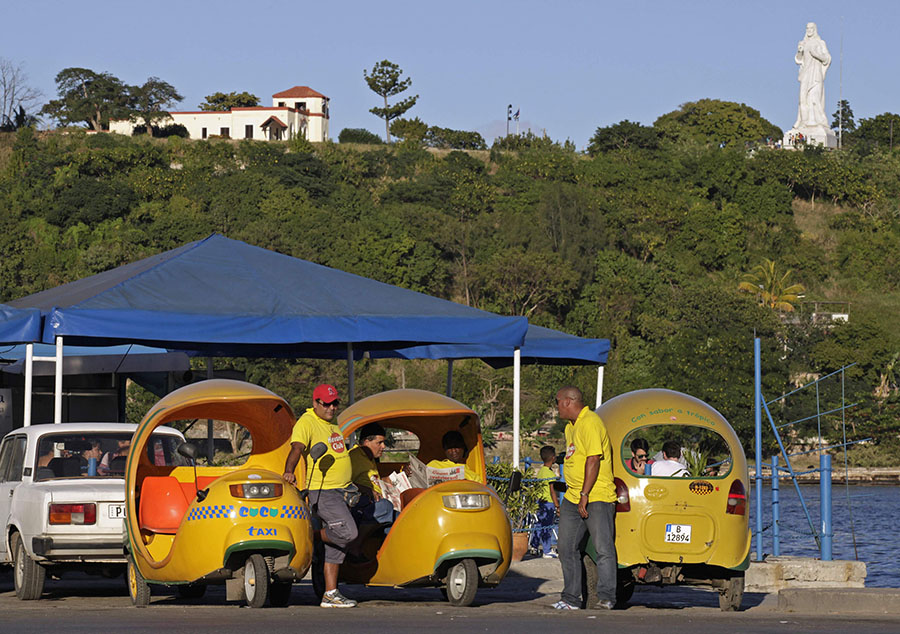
xmin=750 ymin=480 xmax=900 ymax=588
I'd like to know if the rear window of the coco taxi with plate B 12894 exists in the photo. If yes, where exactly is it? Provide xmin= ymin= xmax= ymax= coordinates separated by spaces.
xmin=621 ymin=424 xmax=733 ymax=478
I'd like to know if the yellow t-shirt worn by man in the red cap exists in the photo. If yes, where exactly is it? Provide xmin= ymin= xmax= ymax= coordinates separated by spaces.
xmin=291 ymin=407 xmax=353 ymax=490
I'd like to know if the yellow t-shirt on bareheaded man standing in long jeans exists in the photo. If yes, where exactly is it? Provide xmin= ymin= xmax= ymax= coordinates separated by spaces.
xmin=563 ymin=407 xmax=616 ymax=504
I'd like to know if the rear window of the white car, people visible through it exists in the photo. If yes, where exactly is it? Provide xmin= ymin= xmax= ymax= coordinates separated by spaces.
xmin=34 ymin=432 xmax=188 ymax=480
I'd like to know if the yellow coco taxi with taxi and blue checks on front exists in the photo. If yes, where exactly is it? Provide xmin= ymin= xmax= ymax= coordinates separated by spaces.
xmin=125 ymin=379 xmax=312 ymax=607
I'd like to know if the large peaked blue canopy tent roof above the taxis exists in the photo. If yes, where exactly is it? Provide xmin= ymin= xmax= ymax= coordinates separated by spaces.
xmin=10 ymin=234 xmax=528 ymax=358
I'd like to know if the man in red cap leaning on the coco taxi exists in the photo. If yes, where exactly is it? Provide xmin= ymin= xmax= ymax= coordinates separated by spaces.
xmin=282 ymin=383 xmax=357 ymax=608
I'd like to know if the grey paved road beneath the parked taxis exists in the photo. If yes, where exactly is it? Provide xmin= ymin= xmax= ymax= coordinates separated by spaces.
xmin=0 ymin=561 xmax=900 ymax=634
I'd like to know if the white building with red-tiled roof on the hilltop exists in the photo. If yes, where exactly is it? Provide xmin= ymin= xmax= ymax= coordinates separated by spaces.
xmin=109 ymin=86 xmax=329 ymax=141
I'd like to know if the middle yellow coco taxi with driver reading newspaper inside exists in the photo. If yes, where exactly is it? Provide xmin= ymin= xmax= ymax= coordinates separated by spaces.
xmin=328 ymin=389 xmax=512 ymax=605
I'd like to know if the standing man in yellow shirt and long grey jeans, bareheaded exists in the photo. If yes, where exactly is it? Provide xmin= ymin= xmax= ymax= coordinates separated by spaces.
xmin=553 ymin=386 xmax=617 ymax=610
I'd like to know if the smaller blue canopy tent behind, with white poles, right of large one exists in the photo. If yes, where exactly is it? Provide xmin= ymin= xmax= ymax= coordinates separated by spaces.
xmin=370 ymin=324 xmax=609 ymax=466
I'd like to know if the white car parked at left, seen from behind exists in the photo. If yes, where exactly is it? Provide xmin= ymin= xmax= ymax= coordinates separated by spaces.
xmin=0 ymin=423 xmax=186 ymax=600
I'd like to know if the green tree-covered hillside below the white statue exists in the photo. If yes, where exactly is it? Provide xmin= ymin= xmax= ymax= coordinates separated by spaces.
xmin=0 ymin=117 xmax=900 ymax=456
